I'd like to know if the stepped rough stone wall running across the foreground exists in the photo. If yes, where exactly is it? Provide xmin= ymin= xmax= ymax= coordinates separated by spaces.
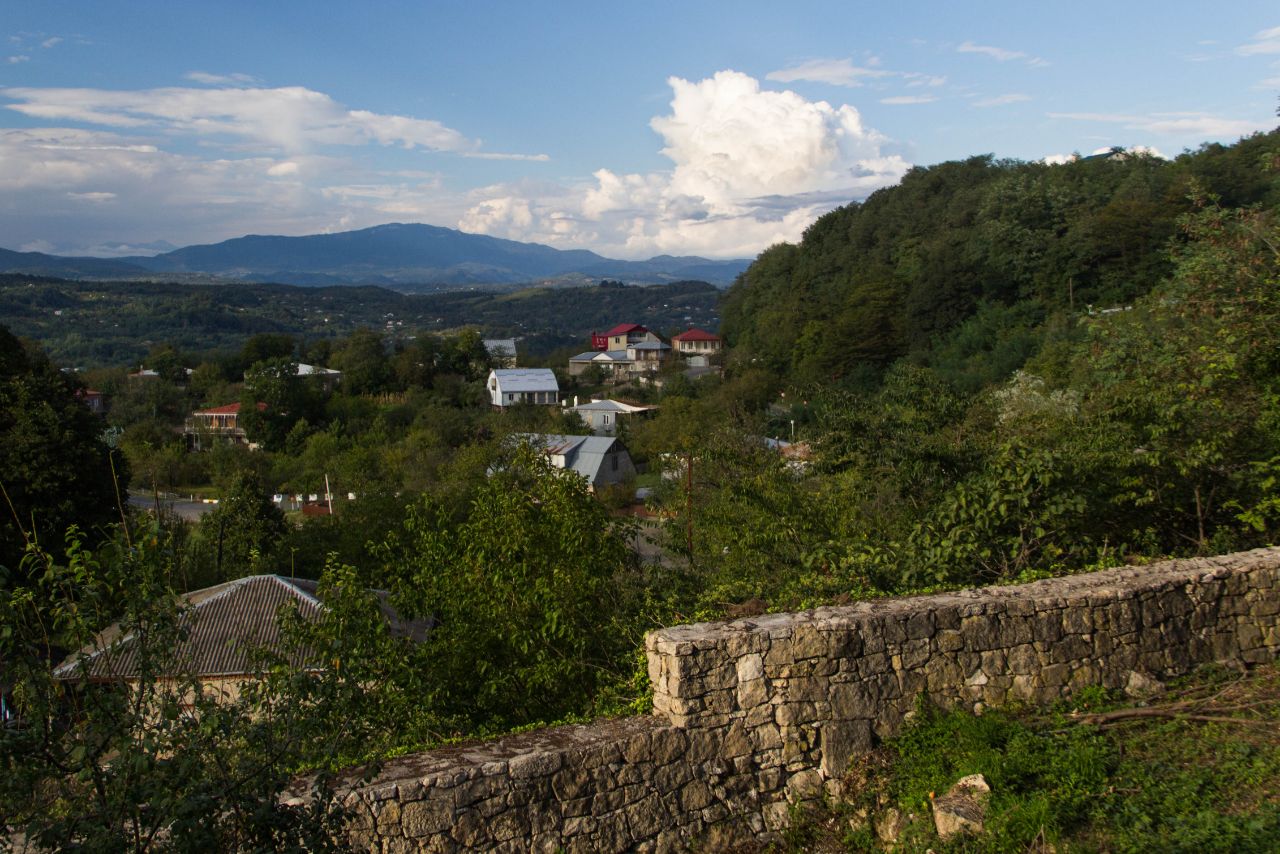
xmin=348 ymin=549 xmax=1280 ymax=851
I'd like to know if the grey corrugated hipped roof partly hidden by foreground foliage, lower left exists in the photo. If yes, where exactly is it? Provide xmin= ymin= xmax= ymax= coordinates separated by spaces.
xmin=54 ymin=575 xmax=433 ymax=679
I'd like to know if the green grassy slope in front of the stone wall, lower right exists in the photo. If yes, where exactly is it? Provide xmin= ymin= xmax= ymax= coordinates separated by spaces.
xmin=773 ymin=665 xmax=1280 ymax=854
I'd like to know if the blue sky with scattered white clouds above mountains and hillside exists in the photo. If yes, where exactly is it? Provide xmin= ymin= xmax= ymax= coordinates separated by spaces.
xmin=0 ymin=0 xmax=1280 ymax=257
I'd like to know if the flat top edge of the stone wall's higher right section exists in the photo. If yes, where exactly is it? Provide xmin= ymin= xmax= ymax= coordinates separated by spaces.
xmin=649 ymin=547 xmax=1280 ymax=649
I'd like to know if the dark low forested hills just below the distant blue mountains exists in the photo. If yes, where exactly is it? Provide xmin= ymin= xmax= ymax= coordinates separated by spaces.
xmin=0 ymin=274 xmax=721 ymax=367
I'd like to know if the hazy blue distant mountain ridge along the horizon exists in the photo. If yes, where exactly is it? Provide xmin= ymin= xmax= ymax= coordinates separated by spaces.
xmin=0 ymin=223 xmax=750 ymax=287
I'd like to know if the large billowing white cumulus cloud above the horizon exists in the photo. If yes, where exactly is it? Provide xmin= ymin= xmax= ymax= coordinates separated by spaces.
xmin=460 ymin=70 xmax=909 ymax=257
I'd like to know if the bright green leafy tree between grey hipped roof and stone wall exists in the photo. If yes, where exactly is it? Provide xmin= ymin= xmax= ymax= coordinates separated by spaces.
xmin=383 ymin=446 xmax=640 ymax=727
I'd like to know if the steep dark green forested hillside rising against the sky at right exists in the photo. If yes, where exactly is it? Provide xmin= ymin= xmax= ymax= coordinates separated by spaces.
xmin=723 ymin=132 xmax=1280 ymax=388
